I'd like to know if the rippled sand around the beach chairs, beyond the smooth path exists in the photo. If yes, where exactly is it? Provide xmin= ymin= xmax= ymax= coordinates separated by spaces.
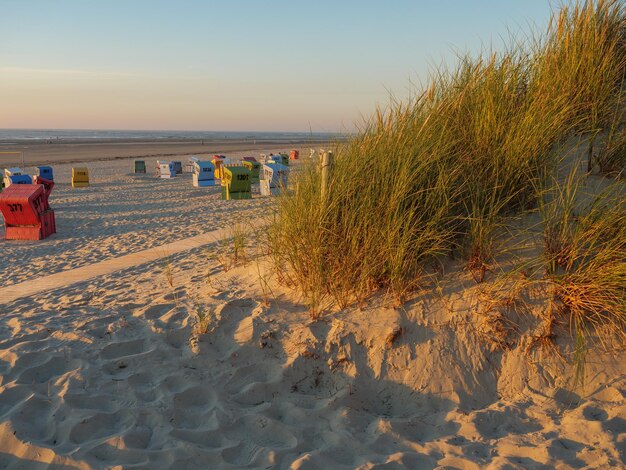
xmin=0 ymin=153 xmax=268 ymax=286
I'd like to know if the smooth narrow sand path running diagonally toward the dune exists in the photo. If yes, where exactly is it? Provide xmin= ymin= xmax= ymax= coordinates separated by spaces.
xmin=0 ymin=219 xmax=262 ymax=305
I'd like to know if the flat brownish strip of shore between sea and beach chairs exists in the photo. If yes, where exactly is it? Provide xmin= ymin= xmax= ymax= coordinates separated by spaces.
xmin=0 ymin=139 xmax=336 ymax=168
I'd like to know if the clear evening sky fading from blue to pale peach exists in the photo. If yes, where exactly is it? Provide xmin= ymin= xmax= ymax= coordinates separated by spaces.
xmin=0 ymin=0 xmax=551 ymax=132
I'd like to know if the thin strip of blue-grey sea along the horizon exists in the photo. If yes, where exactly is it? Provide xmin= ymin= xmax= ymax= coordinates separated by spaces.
xmin=0 ymin=129 xmax=346 ymax=143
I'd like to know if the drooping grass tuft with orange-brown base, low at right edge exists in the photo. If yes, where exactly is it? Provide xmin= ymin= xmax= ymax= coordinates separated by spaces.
xmin=541 ymin=171 xmax=626 ymax=381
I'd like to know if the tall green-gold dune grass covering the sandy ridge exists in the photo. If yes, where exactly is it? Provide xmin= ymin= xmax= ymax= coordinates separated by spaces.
xmin=269 ymin=0 xmax=626 ymax=356
